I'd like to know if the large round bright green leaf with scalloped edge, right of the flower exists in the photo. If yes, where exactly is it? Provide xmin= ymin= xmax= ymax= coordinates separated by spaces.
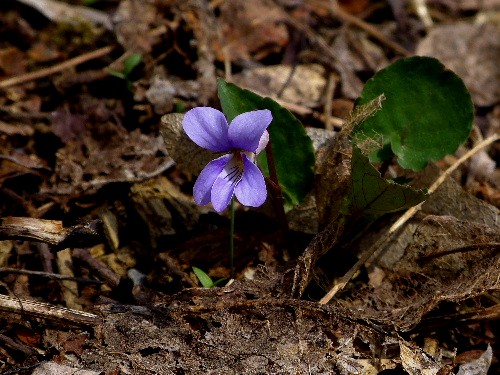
xmin=353 ymin=57 xmax=474 ymax=170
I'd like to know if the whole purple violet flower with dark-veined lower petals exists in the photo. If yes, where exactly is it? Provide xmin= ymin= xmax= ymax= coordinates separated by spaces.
xmin=182 ymin=107 xmax=273 ymax=212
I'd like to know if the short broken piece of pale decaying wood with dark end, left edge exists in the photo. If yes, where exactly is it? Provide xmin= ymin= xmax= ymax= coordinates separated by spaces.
xmin=0 ymin=217 xmax=103 ymax=249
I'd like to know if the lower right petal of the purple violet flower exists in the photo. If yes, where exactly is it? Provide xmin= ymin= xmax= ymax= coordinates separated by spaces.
xmin=234 ymin=155 xmax=267 ymax=207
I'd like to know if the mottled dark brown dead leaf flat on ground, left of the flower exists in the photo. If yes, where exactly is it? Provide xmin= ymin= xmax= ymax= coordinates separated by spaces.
xmin=41 ymin=123 xmax=174 ymax=194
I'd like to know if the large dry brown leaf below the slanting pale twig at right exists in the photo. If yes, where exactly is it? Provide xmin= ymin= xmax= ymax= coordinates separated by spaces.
xmin=346 ymin=180 xmax=500 ymax=330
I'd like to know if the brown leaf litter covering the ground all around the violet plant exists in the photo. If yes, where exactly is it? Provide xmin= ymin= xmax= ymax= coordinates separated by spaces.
xmin=0 ymin=0 xmax=500 ymax=374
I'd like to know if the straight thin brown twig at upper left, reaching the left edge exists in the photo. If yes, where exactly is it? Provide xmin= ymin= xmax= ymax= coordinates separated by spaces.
xmin=0 ymin=46 xmax=114 ymax=89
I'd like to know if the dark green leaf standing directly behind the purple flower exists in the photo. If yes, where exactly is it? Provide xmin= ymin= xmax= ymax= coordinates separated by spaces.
xmin=218 ymin=79 xmax=314 ymax=207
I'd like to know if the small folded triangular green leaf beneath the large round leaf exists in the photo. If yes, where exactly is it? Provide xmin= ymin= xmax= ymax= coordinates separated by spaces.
xmin=348 ymin=146 xmax=426 ymax=215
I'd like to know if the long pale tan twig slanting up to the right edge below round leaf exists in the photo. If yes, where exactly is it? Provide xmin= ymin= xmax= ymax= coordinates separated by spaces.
xmin=319 ymin=135 xmax=500 ymax=305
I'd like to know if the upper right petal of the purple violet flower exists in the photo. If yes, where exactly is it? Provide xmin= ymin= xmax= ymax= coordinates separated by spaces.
xmin=229 ymin=109 xmax=273 ymax=152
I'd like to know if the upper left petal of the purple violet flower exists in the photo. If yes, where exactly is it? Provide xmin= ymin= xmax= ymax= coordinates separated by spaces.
xmin=182 ymin=107 xmax=231 ymax=152
